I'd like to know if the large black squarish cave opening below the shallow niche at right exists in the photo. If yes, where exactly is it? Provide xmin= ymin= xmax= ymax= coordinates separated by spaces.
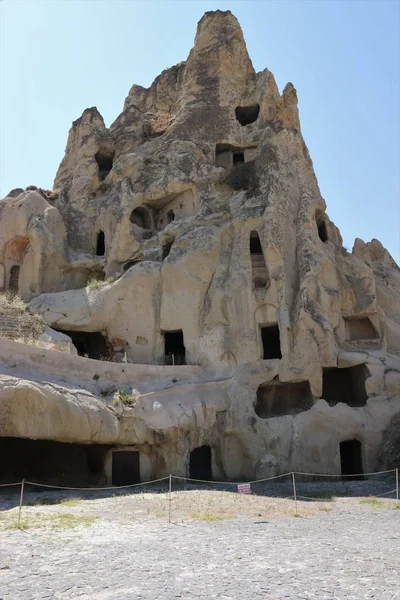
xmin=322 ymin=365 xmax=369 ymax=407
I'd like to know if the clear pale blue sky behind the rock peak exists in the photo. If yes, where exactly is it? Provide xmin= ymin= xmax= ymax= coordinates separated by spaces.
xmin=0 ymin=0 xmax=400 ymax=262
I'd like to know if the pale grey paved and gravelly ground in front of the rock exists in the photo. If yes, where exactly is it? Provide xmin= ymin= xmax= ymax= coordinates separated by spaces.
xmin=0 ymin=482 xmax=400 ymax=600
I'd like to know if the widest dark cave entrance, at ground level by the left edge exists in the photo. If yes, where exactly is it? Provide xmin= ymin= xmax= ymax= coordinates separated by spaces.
xmin=0 ymin=437 xmax=109 ymax=486
